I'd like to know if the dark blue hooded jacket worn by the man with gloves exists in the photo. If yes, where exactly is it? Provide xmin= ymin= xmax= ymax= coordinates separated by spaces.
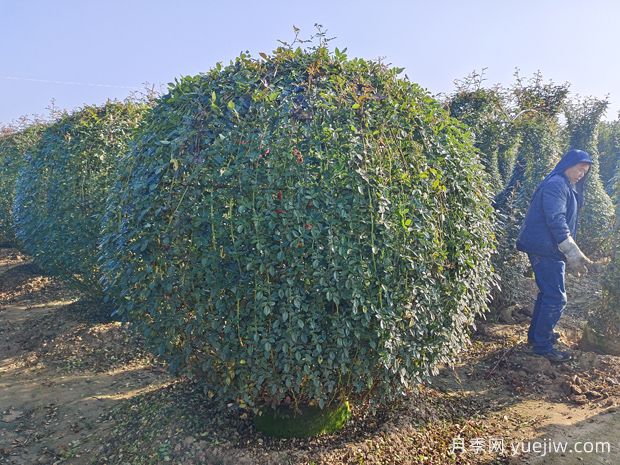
xmin=517 ymin=149 xmax=592 ymax=260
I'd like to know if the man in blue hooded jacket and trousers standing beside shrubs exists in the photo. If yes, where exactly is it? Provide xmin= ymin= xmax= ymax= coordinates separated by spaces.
xmin=517 ymin=149 xmax=592 ymax=362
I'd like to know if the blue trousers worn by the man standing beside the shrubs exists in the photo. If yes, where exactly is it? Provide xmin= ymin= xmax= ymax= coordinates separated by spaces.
xmin=527 ymin=254 xmax=566 ymax=354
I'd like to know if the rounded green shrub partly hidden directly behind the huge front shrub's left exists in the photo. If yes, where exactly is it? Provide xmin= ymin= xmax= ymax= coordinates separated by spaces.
xmin=14 ymin=102 xmax=146 ymax=292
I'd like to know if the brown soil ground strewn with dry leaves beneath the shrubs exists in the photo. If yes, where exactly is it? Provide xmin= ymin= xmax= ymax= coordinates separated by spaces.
xmin=0 ymin=248 xmax=620 ymax=465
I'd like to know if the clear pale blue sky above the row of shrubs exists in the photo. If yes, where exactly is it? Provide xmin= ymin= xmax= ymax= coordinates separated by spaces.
xmin=0 ymin=0 xmax=620 ymax=125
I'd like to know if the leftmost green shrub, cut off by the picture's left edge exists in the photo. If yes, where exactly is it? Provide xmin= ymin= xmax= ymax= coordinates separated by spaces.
xmin=0 ymin=122 xmax=45 ymax=245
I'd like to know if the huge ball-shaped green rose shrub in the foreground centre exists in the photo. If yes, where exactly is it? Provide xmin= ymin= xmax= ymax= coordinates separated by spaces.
xmin=102 ymin=47 xmax=494 ymax=407
